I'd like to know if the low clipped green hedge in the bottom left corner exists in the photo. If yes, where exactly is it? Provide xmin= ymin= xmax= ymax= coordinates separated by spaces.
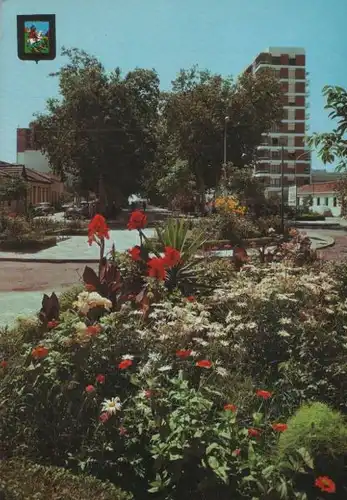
xmin=0 ymin=460 xmax=131 ymax=500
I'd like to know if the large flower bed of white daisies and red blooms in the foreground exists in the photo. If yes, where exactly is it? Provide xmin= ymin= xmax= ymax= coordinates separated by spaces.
xmin=0 ymin=211 xmax=347 ymax=500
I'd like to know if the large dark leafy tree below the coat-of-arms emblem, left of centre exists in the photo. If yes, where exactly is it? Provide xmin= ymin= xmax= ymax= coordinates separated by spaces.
xmin=32 ymin=48 xmax=160 ymax=211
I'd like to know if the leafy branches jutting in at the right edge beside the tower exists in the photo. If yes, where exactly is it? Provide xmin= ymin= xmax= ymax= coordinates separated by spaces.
xmin=308 ymin=85 xmax=347 ymax=172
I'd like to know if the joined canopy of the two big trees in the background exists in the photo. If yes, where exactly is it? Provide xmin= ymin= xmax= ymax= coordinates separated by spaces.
xmin=32 ymin=48 xmax=283 ymax=209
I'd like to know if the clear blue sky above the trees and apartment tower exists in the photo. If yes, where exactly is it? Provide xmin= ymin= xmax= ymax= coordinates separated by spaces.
xmin=0 ymin=0 xmax=347 ymax=168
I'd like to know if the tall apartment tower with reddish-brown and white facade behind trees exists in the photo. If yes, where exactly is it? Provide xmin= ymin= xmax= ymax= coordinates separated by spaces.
xmin=246 ymin=47 xmax=311 ymax=199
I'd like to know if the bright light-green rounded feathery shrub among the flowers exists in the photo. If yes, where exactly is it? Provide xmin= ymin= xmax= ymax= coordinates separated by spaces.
xmin=278 ymin=403 xmax=347 ymax=458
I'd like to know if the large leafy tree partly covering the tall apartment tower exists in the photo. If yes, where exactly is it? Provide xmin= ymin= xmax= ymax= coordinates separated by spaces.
xmin=162 ymin=67 xmax=283 ymax=210
